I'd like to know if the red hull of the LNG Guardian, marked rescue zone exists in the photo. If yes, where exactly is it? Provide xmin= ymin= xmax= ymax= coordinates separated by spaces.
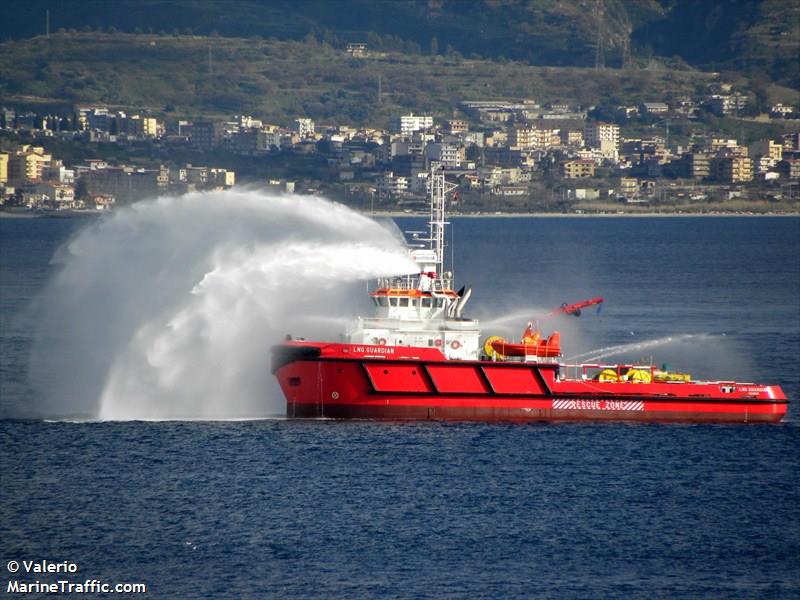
xmin=273 ymin=342 xmax=788 ymax=423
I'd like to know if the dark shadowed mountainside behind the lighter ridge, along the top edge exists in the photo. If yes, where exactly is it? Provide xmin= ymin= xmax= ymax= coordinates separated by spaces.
xmin=0 ymin=0 xmax=800 ymax=88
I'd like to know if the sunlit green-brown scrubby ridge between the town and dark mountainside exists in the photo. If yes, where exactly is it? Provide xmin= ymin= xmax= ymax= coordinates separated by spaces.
xmin=0 ymin=33 xmax=712 ymax=125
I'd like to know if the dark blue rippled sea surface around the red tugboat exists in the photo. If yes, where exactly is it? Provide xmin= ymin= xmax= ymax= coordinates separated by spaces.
xmin=0 ymin=217 xmax=800 ymax=599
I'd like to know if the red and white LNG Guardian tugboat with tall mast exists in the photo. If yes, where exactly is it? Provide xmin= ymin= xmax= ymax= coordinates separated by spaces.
xmin=272 ymin=171 xmax=788 ymax=423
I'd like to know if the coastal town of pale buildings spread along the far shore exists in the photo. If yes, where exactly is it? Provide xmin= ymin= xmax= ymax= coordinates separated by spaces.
xmin=0 ymin=81 xmax=800 ymax=212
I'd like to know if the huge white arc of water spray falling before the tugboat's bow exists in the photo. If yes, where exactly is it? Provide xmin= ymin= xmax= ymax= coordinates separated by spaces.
xmin=31 ymin=190 xmax=414 ymax=420
